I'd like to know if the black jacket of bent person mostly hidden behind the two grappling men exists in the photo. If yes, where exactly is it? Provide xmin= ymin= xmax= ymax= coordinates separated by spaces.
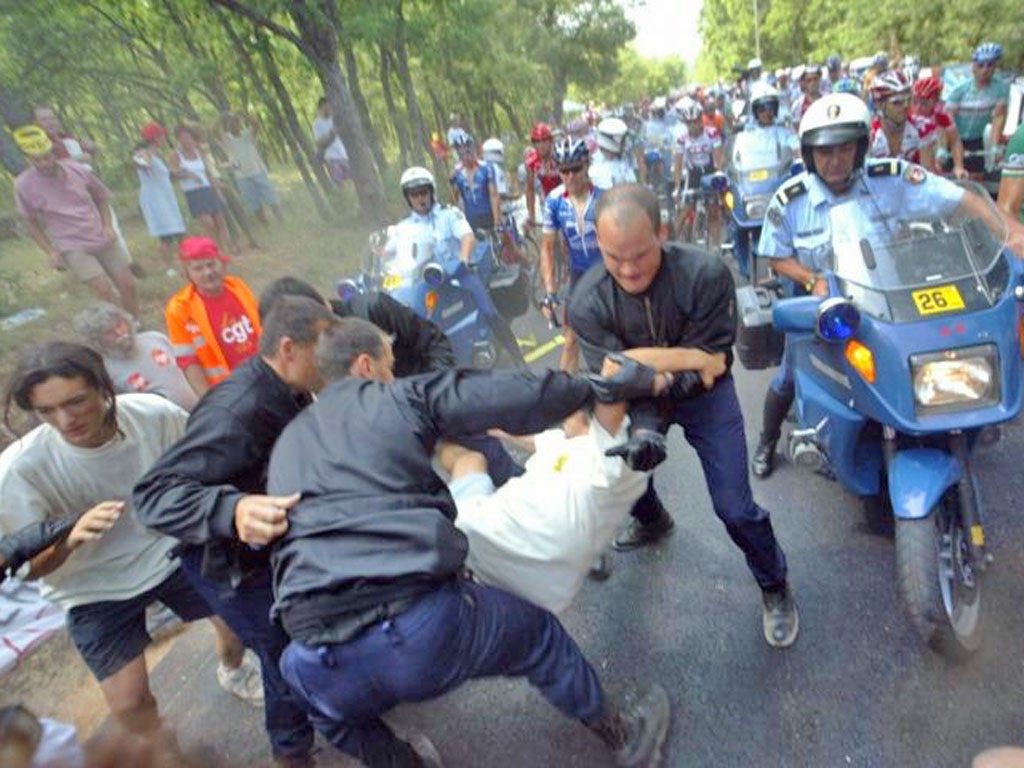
xmin=331 ymin=293 xmax=455 ymax=377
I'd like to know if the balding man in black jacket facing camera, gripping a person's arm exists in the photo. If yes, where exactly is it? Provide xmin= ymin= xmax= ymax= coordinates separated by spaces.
xmin=569 ymin=184 xmax=799 ymax=647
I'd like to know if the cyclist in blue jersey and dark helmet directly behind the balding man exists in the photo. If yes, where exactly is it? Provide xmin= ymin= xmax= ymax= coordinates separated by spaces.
xmin=541 ymin=137 xmax=601 ymax=373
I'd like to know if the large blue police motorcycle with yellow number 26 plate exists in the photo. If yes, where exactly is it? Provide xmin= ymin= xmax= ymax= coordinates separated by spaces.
xmin=774 ymin=190 xmax=1024 ymax=656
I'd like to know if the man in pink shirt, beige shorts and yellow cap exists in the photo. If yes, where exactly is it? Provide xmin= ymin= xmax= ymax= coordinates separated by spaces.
xmin=14 ymin=125 xmax=138 ymax=317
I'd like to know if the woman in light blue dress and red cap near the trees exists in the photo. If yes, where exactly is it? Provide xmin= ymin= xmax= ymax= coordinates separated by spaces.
xmin=132 ymin=123 xmax=185 ymax=274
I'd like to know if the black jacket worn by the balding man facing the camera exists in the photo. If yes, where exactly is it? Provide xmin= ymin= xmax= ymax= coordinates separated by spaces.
xmin=568 ymin=243 xmax=736 ymax=428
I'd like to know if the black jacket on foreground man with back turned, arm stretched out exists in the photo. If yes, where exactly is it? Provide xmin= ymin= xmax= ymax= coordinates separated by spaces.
xmin=268 ymin=370 xmax=592 ymax=643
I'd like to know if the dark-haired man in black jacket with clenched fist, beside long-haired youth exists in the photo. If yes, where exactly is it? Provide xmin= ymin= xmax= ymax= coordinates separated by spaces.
xmin=133 ymin=297 xmax=335 ymax=766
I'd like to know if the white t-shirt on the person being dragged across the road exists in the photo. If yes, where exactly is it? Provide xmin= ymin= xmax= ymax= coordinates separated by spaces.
xmin=456 ymin=419 xmax=648 ymax=613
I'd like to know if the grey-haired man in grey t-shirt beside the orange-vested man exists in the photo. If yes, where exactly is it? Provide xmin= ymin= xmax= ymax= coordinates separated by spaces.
xmin=75 ymin=302 xmax=199 ymax=411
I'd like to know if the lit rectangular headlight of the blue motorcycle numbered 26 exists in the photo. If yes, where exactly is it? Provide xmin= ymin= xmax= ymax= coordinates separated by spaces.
xmin=910 ymin=344 xmax=999 ymax=413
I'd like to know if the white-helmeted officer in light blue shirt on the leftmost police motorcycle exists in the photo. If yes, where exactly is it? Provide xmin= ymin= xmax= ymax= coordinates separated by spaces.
xmin=387 ymin=166 xmax=522 ymax=362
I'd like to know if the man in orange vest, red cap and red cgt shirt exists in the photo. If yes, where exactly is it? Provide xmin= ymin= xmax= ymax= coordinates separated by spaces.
xmin=164 ymin=238 xmax=260 ymax=397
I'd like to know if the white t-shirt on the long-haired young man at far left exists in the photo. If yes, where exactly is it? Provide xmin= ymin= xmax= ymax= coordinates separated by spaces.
xmin=0 ymin=394 xmax=188 ymax=610
